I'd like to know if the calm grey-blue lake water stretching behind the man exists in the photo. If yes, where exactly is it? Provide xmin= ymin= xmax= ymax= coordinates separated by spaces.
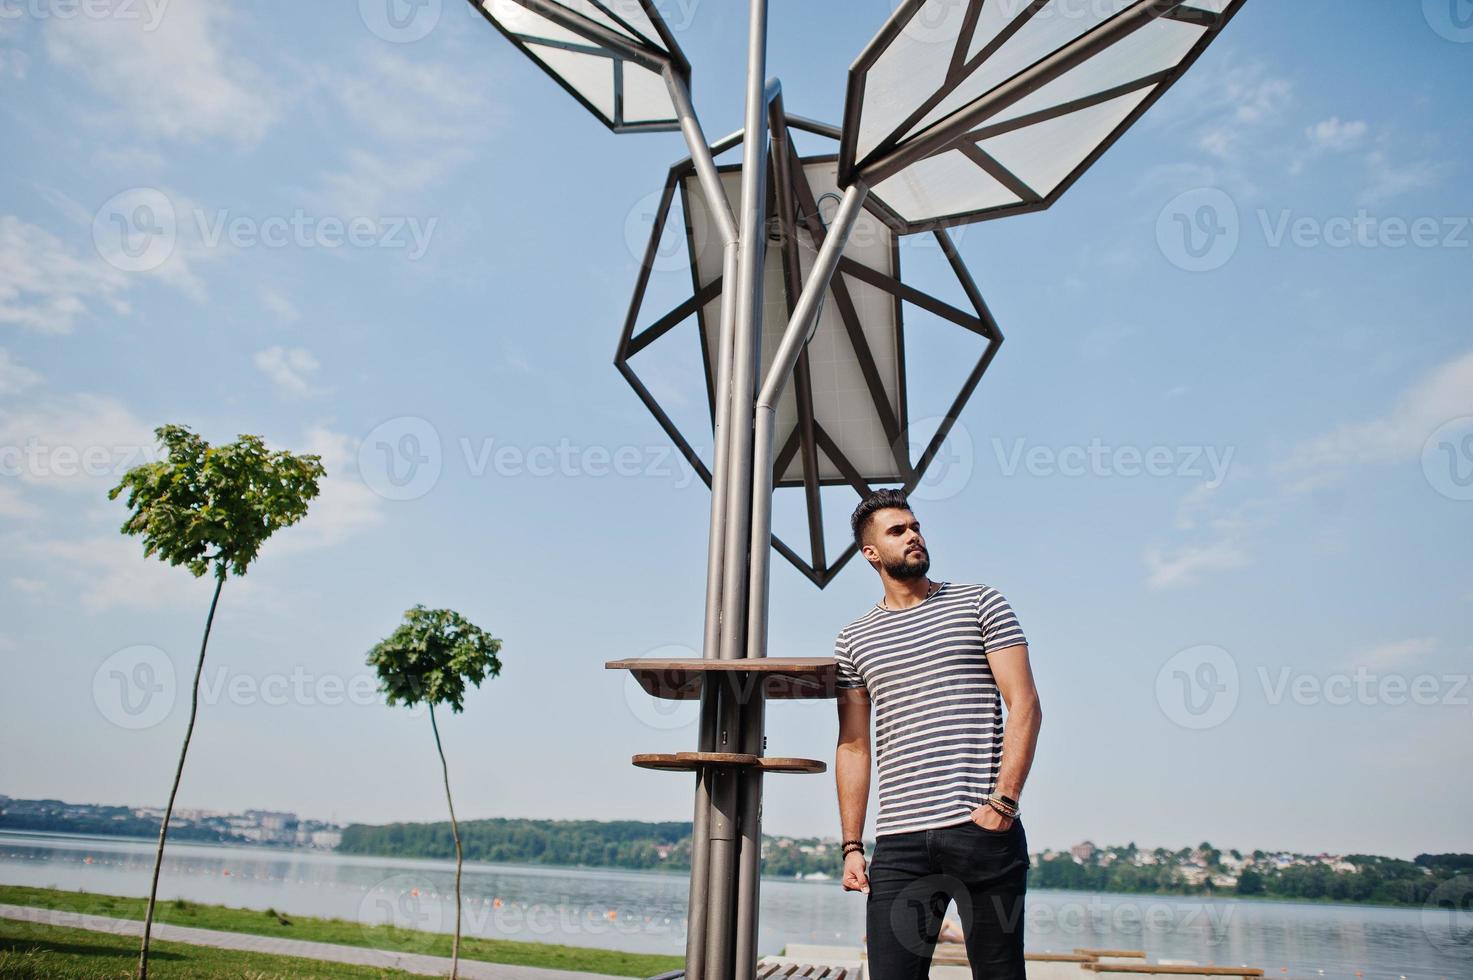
xmin=0 ymin=833 xmax=1473 ymax=980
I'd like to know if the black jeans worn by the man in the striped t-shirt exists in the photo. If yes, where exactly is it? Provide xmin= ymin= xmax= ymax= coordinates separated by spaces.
xmin=865 ymin=818 xmax=1030 ymax=980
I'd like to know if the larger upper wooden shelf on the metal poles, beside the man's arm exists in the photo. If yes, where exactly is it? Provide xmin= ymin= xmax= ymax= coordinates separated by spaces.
xmin=604 ymin=657 xmax=838 ymax=701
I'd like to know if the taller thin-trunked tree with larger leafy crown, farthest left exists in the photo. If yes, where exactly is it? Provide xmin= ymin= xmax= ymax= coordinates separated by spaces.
xmin=108 ymin=424 xmax=324 ymax=980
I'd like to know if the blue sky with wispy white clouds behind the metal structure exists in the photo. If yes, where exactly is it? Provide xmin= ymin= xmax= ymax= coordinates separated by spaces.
xmin=0 ymin=0 xmax=1473 ymax=856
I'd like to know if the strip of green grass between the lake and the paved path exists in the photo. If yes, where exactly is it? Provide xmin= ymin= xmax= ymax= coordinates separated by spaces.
xmin=0 ymin=884 xmax=685 ymax=977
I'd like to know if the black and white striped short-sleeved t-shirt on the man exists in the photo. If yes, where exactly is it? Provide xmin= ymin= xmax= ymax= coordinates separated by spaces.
xmin=834 ymin=582 xmax=1028 ymax=837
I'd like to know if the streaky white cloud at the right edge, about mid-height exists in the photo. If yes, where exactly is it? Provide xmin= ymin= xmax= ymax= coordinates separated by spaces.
xmin=1280 ymin=351 xmax=1473 ymax=475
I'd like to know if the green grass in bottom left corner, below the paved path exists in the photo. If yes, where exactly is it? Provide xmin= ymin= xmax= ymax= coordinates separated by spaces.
xmin=0 ymin=920 xmax=411 ymax=980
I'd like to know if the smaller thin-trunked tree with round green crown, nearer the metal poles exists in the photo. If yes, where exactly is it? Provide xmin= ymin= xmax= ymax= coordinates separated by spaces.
xmin=368 ymin=606 xmax=501 ymax=980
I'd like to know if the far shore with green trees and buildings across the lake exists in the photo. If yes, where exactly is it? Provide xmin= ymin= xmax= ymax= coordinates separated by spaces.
xmin=0 ymin=796 xmax=1473 ymax=906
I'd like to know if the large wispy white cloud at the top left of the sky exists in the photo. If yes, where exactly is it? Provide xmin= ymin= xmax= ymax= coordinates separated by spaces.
xmin=46 ymin=0 xmax=275 ymax=146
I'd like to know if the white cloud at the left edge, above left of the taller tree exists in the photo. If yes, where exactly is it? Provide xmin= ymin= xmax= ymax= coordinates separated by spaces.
xmin=0 ymin=215 xmax=128 ymax=333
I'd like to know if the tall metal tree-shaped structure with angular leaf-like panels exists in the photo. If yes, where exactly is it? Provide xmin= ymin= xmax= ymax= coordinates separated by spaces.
xmin=470 ymin=0 xmax=1245 ymax=980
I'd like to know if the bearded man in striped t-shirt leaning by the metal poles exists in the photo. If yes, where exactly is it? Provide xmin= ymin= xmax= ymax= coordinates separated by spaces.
xmin=834 ymin=489 xmax=1043 ymax=980
